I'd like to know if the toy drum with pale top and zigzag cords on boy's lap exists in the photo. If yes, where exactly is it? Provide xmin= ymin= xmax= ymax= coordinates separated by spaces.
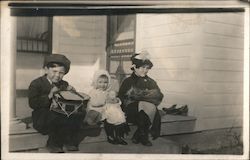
xmin=50 ymin=91 xmax=89 ymax=117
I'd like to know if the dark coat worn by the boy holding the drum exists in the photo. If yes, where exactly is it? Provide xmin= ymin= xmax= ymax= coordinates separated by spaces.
xmin=28 ymin=75 xmax=68 ymax=134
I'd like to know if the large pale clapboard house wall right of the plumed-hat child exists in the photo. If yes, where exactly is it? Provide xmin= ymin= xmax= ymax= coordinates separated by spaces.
xmin=136 ymin=13 xmax=244 ymax=130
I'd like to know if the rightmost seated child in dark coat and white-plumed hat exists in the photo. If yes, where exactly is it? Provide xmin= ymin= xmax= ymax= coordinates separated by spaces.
xmin=118 ymin=52 xmax=163 ymax=146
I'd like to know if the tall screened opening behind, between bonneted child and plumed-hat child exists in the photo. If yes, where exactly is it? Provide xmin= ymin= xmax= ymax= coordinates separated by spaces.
xmin=107 ymin=15 xmax=135 ymax=84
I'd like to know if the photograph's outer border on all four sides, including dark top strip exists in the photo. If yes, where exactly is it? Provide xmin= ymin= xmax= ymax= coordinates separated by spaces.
xmin=0 ymin=0 xmax=250 ymax=160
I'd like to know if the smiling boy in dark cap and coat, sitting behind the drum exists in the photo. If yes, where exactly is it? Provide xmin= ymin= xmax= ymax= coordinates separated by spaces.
xmin=28 ymin=54 xmax=84 ymax=153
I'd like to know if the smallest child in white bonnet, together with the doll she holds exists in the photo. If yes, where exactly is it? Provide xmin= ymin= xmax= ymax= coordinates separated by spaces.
xmin=84 ymin=70 xmax=128 ymax=145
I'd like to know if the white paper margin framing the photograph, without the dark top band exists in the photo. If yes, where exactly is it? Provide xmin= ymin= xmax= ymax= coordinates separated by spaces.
xmin=1 ymin=0 xmax=250 ymax=160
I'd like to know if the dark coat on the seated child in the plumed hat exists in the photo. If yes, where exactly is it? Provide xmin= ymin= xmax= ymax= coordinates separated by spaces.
xmin=118 ymin=73 xmax=163 ymax=138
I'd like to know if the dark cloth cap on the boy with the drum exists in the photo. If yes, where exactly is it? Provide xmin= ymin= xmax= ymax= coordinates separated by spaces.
xmin=43 ymin=54 xmax=71 ymax=74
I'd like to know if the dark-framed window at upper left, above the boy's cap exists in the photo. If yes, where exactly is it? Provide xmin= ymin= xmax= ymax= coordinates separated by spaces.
xmin=17 ymin=17 xmax=52 ymax=54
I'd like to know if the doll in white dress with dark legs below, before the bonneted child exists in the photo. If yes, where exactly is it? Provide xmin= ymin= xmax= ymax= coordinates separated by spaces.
xmin=103 ymin=91 xmax=129 ymax=145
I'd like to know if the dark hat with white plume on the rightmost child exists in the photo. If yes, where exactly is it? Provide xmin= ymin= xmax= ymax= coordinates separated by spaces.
xmin=131 ymin=51 xmax=153 ymax=68
